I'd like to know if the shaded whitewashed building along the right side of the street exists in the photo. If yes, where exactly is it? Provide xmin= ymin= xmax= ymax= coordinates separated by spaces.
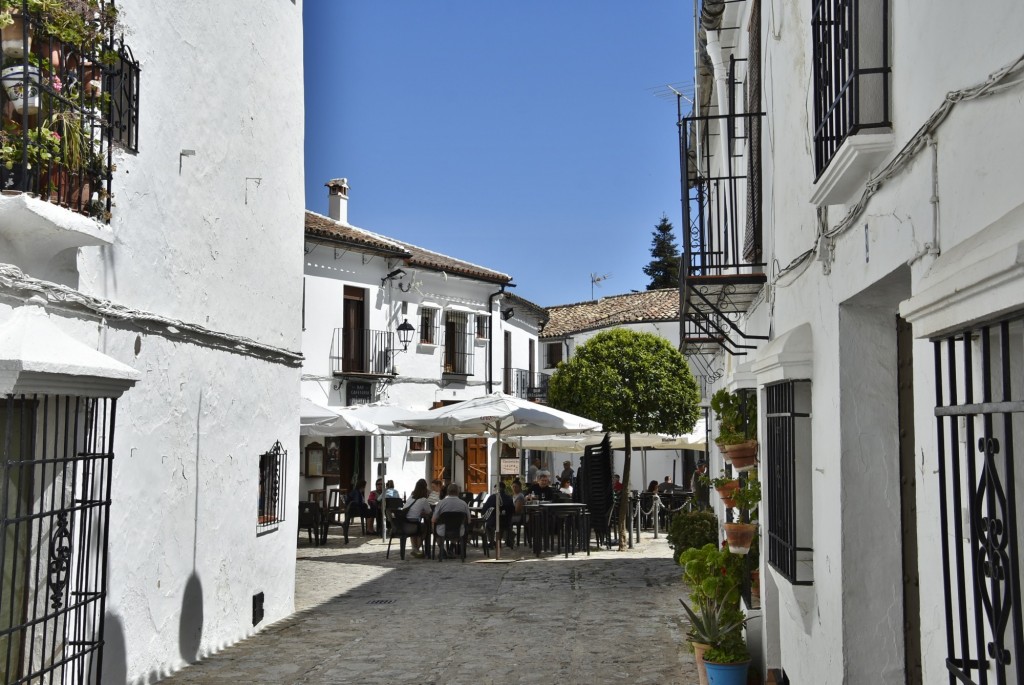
xmin=680 ymin=0 xmax=1024 ymax=684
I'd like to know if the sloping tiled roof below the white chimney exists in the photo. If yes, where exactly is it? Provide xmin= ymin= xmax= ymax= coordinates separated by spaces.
xmin=306 ymin=211 xmax=512 ymax=284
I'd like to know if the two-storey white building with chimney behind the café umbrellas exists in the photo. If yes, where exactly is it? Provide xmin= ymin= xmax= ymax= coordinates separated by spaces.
xmin=301 ymin=178 xmax=544 ymax=497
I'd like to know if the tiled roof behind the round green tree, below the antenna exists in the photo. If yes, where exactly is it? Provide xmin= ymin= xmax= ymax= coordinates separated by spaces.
xmin=541 ymin=288 xmax=679 ymax=338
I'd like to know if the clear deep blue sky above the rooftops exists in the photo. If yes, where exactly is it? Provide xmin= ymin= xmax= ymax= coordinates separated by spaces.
xmin=303 ymin=0 xmax=692 ymax=306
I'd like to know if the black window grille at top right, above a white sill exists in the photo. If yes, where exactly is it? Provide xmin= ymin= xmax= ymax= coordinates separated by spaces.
xmin=811 ymin=0 xmax=891 ymax=176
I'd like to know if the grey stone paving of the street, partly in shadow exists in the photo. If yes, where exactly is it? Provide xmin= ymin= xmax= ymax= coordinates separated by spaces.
xmin=161 ymin=531 xmax=697 ymax=685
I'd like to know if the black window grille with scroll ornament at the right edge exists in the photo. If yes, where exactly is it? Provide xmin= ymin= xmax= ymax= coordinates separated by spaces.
xmin=934 ymin=314 xmax=1024 ymax=685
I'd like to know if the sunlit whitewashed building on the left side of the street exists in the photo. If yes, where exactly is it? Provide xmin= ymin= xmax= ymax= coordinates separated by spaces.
xmin=0 ymin=0 xmax=303 ymax=683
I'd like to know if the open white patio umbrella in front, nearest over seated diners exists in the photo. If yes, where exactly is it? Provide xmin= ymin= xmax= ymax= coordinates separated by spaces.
xmin=396 ymin=392 xmax=601 ymax=559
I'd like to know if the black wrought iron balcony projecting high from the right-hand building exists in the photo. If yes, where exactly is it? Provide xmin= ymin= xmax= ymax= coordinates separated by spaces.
xmin=679 ymin=113 xmax=767 ymax=357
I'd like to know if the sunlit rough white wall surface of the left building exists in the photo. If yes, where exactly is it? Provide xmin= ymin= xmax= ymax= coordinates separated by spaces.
xmin=48 ymin=0 xmax=303 ymax=682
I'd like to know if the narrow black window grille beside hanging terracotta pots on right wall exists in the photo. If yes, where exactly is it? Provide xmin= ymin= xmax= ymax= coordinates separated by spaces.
xmin=764 ymin=381 xmax=813 ymax=585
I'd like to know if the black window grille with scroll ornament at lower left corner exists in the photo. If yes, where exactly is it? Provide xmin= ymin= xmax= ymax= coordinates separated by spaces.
xmin=0 ymin=395 xmax=116 ymax=683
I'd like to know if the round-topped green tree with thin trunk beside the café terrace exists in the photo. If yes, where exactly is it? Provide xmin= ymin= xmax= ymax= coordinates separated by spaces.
xmin=548 ymin=329 xmax=700 ymax=550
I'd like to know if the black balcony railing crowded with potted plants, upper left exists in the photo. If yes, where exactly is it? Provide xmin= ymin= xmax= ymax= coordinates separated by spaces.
xmin=0 ymin=0 xmax=139 ymax=221
